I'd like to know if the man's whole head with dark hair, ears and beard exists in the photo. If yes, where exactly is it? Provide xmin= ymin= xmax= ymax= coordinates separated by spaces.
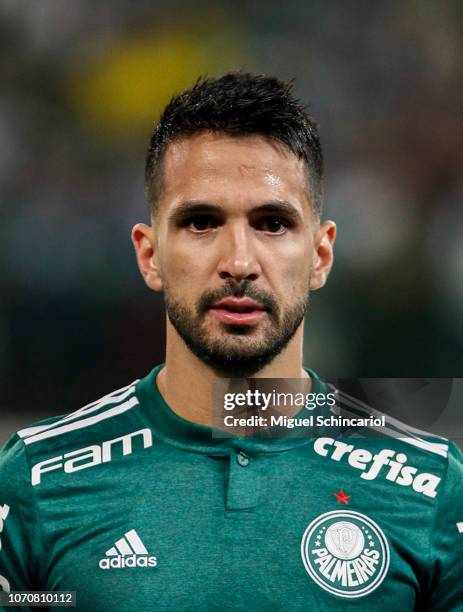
xmin=133 ymin=74 xmax=335 ymax=376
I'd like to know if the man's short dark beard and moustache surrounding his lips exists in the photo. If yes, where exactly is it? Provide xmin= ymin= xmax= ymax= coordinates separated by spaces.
xmin=164 ymin=279 xmax=309 ymax=378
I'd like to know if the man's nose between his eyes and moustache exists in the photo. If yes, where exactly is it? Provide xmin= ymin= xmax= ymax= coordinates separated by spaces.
xmin=217 ymin=223 xmax=261 ymax=281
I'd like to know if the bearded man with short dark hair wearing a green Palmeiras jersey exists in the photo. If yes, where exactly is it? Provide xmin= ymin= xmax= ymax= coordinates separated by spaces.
xmin=0 ymin=73 xmax=463 ymax=612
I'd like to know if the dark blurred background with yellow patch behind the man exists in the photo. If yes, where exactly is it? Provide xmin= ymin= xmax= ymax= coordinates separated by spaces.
xmin=0 ymin=0 xmax=463 ymax=443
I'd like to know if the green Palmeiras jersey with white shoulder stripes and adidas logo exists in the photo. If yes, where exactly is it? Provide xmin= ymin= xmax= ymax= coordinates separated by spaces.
xmin=0 ymin=367 xmax=463 ymax=612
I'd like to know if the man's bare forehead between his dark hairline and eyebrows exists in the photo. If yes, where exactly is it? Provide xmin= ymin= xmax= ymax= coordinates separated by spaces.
xmin=161 ymin=132 xmax=307 ymax=208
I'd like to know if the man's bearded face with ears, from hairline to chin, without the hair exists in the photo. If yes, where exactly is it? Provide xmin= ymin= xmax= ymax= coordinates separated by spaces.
xmin=133 ymin=133 xmax=335 ymax=376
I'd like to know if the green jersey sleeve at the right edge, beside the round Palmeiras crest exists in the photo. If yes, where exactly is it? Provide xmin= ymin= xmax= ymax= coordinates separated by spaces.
xmin=427 ymin=443 xmax=463 ymax=612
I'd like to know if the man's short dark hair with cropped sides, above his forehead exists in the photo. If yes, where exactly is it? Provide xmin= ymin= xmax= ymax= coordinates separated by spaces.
xmin=145 ymin=72 xmax=323 ymax=215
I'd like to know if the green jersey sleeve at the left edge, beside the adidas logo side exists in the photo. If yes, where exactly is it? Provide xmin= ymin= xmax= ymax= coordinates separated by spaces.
xmin=0 ymin=435 xmax=41 ymax=591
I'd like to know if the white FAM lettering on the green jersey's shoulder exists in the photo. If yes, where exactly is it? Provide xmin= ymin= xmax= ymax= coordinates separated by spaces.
xmin=31 ymin=429 xmax=153 ymax=486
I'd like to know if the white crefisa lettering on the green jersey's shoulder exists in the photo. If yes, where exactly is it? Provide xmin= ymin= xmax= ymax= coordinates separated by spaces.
xmin=314 ymin=438 xmax=441 ymax=497
